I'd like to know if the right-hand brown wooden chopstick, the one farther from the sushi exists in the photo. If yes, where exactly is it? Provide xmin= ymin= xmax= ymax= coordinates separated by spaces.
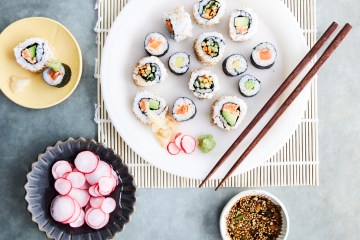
xmin=215 ymin=23 xmax=352 ymax=191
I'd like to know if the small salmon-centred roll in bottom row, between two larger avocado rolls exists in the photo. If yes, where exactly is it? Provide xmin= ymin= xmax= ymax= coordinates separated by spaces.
xmin=172 ymin=97 xmax=196 ymax=122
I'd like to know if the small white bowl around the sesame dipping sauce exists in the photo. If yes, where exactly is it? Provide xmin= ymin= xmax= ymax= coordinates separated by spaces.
xmin=220 ymin=190 xmax=290 ymax=240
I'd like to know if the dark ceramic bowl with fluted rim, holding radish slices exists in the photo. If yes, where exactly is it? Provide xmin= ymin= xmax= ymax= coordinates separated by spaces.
xmin=25 ymin=138 xmax=135 ymax=240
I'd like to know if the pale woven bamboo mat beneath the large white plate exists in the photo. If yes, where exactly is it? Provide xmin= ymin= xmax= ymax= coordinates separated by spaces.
xmin=94 ymin=0 xmax=319 ymax=188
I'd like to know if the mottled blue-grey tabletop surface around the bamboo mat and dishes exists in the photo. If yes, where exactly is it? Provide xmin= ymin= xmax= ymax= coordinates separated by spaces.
xmin=0 ymin=0 xmax=360 ymax=240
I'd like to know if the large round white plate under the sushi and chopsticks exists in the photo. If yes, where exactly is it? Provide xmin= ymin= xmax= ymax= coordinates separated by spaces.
xmin=101 ymin=0 xmax=310 ymax=179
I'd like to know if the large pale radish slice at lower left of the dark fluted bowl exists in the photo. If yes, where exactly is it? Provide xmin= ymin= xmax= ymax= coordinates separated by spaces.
xmin=50 ymin=196 xmax=75 ymax=222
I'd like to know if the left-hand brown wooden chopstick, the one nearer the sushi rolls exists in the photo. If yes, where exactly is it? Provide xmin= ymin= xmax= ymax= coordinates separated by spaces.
xmin=199 ymin=22 xmax=338 ymax=187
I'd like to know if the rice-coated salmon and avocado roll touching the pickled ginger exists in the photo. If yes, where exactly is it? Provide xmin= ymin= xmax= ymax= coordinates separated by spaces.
xmin=133 ymin=91 xmax=169 ymax=124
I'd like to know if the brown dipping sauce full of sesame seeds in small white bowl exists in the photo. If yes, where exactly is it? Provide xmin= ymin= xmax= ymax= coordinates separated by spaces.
xmin=226 ymin=195 xmax=282 ymax=240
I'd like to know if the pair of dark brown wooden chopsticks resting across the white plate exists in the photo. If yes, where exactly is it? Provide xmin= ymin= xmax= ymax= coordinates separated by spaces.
xmin=199 ymin=22 xmax=352 ymax=191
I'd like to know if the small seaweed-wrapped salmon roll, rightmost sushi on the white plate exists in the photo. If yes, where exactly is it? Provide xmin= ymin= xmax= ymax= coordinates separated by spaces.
xmin=251 ymin=42 xmax=277 ymax=69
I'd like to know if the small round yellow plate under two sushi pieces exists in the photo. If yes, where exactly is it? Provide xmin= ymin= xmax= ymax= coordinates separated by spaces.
xmin=0 ymin=17 xmax=82 ymax=109
